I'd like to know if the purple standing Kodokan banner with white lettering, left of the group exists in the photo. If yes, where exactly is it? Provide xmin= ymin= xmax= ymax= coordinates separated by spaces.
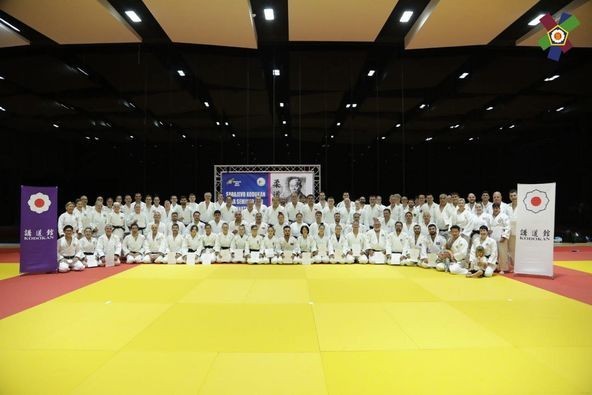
xmin=20 ymin=185 xmax=58 ymax=273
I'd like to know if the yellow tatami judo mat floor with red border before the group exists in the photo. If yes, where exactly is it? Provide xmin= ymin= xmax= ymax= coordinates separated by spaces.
xmin=0 ymin=249 xmax=592 ymax=395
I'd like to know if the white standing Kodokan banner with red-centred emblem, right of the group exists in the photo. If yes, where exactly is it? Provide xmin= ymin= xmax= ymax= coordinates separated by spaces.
xmin=514 ymin=183 xmax=555 ymax=277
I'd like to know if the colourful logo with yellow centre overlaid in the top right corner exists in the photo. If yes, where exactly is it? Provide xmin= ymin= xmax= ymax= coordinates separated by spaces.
xmin=539 ymin=12 xmax=580 ymax=62
